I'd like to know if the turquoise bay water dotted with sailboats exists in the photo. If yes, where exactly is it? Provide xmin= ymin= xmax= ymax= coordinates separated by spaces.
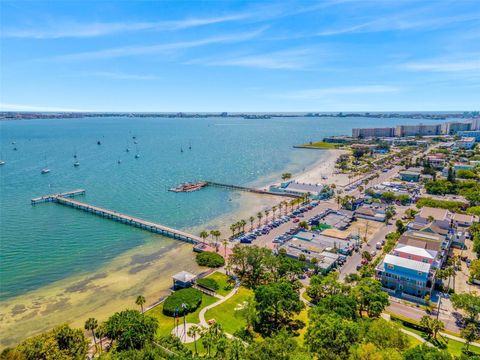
xmin=0 ymin=118 xmax=446 ymax=300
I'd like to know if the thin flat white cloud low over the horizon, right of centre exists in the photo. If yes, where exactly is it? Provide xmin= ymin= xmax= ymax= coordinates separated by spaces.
xmin=275 ymin=85 xmax=399 ymax=100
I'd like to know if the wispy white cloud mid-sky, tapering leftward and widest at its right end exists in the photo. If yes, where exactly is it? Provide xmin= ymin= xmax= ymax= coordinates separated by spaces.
xmin=188 ymin=49 xmax=312 ymax=70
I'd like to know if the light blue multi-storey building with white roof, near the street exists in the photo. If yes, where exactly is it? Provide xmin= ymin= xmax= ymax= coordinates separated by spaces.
xmin=375 ymin=254 xmax=435 ymax=299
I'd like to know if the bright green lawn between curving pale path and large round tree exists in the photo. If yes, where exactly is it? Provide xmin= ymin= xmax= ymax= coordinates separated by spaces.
xmin=205 ymin=287 xmax=253 ymax=334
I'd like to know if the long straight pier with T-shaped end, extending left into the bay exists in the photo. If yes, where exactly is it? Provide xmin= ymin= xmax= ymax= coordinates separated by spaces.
xmin=32 ymin=190 xmax=203 ymax=245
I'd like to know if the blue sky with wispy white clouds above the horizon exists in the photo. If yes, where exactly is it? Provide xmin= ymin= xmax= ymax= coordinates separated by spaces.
xmin=0 ymin=0 xmax=480 ymax=112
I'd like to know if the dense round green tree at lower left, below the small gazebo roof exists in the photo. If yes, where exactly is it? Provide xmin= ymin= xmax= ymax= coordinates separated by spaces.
xmin=103 ymin=310 xmax=158 ymax=351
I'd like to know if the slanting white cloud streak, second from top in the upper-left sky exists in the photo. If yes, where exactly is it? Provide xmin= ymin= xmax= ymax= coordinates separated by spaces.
xmin=48 ymin=27 xmax=266 ymax=61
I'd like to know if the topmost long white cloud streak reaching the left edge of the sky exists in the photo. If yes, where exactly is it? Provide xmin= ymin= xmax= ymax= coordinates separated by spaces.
xmin=2 ymin=13 xmax=250 ymax=39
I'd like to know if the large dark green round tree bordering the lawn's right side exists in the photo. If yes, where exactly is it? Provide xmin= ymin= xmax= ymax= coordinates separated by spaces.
xmin=255 ymin=280 xmax=304 ymax=334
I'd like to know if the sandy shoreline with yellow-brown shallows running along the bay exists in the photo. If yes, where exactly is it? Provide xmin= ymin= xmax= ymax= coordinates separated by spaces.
xmin=0 ymin=150 xmax=340 ymax=348
